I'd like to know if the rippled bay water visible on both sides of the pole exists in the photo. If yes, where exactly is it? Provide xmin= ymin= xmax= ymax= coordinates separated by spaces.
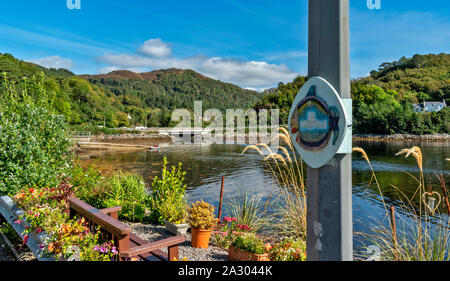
xmin=79 ymin=141 xmax=450 ymax=253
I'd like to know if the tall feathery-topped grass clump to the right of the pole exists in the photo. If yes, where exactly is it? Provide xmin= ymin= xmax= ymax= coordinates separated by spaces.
xmin=353 ymin=146 xmax=450 ymax=261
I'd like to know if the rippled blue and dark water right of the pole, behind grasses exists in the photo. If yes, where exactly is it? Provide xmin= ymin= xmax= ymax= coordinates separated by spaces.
xmin=352 ymin=141 xmax=450 ymax=252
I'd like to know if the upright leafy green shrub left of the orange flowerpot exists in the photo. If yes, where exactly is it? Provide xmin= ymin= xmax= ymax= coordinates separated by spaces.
xmin=148 ymin=158 xmax=186 ymax=224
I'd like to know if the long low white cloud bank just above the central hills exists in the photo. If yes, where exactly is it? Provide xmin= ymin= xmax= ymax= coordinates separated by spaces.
xmin=98 ymin=37 xmax=298 ymax=88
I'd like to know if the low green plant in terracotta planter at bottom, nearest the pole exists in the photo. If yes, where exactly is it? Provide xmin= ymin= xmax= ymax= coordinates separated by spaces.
xmin=228 ymin=233 xmax=270 ymax=261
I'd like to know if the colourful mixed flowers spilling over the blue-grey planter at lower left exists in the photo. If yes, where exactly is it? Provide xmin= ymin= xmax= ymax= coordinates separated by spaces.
xmin=1 ymin=181 xmax=118 ymax=261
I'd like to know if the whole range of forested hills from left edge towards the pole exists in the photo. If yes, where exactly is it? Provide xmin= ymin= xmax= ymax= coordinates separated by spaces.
xmin=0 ymin=53 xmax=261 ymax=127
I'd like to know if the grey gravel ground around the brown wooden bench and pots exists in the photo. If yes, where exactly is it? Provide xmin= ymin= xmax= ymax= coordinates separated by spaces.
xmin=129 ymin=223 xmax=228 ymax=261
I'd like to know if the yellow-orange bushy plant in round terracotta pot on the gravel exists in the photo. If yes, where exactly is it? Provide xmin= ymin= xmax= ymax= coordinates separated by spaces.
xmin=188 ymin=200 xmax=217 ymax=249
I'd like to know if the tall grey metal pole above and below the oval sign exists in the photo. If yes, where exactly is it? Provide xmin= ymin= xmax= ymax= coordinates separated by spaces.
xmin=307 ymin=0 xmax=353 ymax=261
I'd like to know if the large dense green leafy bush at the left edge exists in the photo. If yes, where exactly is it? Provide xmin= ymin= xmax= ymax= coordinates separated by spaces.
xmin=0 ymin=72 xmax=72 ymax=195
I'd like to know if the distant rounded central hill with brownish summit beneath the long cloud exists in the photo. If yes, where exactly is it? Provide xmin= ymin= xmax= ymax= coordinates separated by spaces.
xmin=80 ymin=68 xmax=261 ymax=110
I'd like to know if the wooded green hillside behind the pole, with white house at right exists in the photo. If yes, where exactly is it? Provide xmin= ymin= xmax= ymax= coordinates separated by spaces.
xmin=254 ymin=54 xmax=450 ymax=134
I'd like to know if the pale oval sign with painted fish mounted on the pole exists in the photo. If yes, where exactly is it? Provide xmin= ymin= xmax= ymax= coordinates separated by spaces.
xmin=289 ymin=76 xmax=348 ymax=168
